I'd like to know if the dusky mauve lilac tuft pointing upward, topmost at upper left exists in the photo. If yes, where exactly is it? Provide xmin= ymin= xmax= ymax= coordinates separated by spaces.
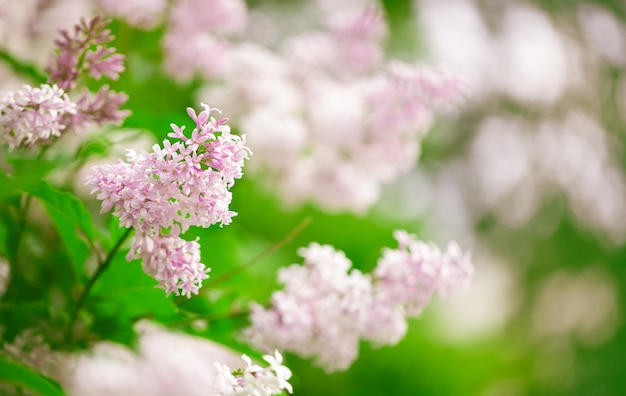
xmin=46 ymin=16 xmax=125 ymax=90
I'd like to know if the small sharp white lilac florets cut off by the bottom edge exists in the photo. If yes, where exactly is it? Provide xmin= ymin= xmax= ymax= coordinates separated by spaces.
xmin=213 ymin=351 xmax=293 ymax=396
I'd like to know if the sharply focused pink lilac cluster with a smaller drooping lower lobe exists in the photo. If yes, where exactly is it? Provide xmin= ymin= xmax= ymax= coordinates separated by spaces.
xmin=86 ymin=104 xmax=250 ymax=297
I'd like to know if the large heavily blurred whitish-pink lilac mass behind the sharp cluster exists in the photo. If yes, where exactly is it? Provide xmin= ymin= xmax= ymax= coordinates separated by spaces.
xmin=202 ymin=4 xmax=466 ymax=213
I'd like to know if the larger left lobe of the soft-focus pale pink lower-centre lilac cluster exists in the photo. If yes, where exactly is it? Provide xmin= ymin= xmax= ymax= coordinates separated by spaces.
xmin=244 ymin=243 xmax=371 ymax=371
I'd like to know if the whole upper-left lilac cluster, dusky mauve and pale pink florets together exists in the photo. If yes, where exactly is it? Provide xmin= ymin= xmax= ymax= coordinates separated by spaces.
xmin=0 ymin=17 xmax=129 ymax=150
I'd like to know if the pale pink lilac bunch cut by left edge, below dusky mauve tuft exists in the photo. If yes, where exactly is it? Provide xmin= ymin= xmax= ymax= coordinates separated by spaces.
xmin=0 ymin=84 xmax=77 ymax=150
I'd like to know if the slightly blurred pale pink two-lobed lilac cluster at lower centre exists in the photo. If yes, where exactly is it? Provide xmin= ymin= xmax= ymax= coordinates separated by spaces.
xmin=244 ymin=231 xmax=473 ymax=372
